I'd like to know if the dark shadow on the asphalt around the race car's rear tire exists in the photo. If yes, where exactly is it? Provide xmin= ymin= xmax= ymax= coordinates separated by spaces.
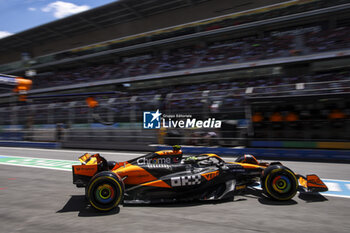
xmin=56 ymin=195 xmax=120 ymax=217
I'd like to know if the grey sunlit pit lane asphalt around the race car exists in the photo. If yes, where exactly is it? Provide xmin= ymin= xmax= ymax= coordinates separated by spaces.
xmin=0 ymin=147 xmax=350 ymax=233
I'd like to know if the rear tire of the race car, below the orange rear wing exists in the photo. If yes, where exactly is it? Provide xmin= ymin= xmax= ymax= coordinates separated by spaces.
xmin=86 ymin=171 xmax=124 ymax=211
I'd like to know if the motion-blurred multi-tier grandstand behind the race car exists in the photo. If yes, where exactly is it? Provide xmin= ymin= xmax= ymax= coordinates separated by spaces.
xmin=0 ymin=0 xmax=350 ymax=149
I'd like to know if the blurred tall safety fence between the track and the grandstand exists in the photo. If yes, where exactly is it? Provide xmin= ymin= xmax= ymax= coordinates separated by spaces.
xmin=0 ymin=80 xmax=350 ymax=148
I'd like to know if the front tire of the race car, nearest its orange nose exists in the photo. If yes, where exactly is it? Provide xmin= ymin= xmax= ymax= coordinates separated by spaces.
xmin=261 ymin=165 xmax=298 ymax=201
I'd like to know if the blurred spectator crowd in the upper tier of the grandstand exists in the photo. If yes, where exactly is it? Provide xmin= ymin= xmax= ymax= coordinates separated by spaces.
xmin=26 ymin=24 xmax=350 ymax=88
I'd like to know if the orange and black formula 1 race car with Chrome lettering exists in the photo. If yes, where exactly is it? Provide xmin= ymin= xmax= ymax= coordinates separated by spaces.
xmin=73 ymin=146 xmax=328 ymax=211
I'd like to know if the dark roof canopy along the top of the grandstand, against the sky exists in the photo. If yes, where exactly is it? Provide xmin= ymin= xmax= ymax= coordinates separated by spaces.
xmin=0 ymin=0 xmax=209 ymax=51
